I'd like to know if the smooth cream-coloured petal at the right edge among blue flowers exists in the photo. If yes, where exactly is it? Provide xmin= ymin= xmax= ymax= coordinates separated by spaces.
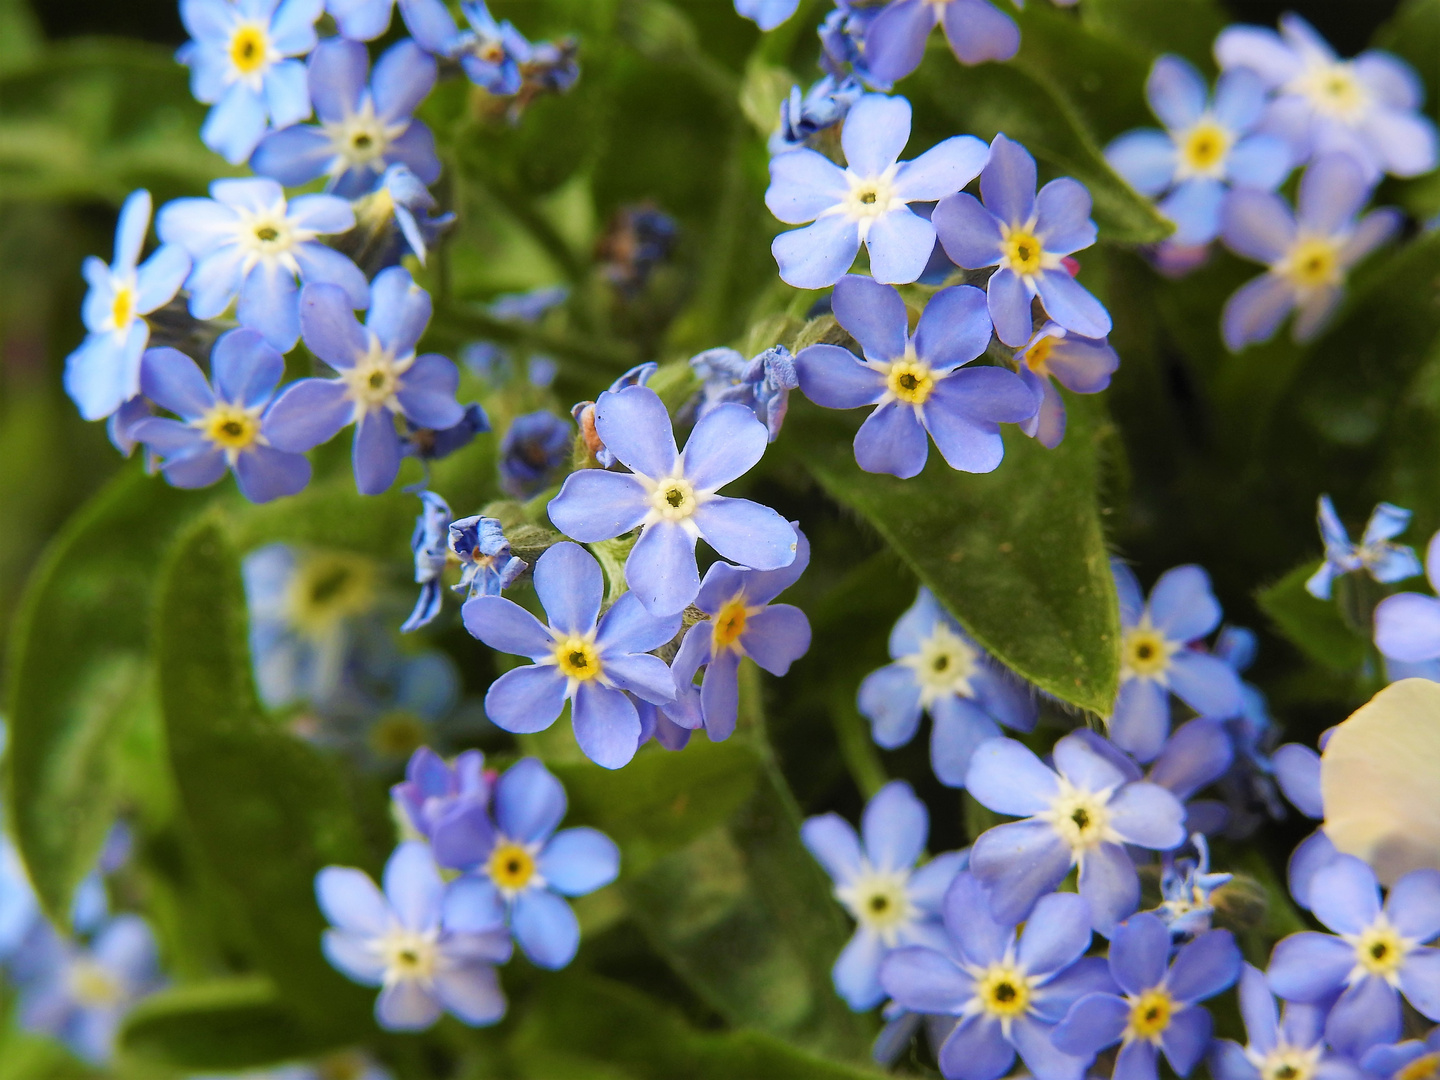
xmin=1320 ymin=678 xmax=1440 ymax=886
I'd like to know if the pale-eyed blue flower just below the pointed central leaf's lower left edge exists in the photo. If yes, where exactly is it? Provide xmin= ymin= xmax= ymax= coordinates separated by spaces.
xmin=858 ymin=586 xmax=1035 ymax=788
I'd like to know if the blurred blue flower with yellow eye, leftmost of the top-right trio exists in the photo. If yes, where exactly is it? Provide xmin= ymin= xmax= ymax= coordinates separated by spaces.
xmin=1104 ymin=55 xmax=1292 ymax=245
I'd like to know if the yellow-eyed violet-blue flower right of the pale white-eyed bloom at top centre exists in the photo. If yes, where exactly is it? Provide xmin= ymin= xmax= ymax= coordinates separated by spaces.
xmin=933 ymin=135 xmax=1110 ymax=348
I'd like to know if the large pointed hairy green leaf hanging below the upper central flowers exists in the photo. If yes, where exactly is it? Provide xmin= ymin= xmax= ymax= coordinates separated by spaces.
xmin=792 ymin=395 xmax=1120 ymax=714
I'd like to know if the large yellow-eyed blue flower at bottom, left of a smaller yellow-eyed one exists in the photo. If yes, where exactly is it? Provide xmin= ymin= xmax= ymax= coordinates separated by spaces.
xmin=880 ymin=873 xmax=1115 ymax=1080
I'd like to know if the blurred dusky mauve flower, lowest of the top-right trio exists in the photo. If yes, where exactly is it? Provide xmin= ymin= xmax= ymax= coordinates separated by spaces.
xmin=1221 ymin=154 xmax=1401 ymax=351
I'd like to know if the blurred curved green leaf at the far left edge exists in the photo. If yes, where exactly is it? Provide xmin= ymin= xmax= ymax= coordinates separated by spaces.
xmin=6 ymin=462 xmax=194 ymax=923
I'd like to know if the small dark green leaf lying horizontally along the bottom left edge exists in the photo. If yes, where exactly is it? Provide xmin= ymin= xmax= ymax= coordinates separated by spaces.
xmin=120 ymin=976 xmax=325 ymax=1068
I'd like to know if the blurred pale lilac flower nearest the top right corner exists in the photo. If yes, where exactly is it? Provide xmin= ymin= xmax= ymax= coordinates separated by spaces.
xmin=1215 ymin=13 xmax=1437 ymax=183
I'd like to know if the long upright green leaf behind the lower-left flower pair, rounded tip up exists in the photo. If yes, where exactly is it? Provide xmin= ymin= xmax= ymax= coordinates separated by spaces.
xmin=156 ymin=518 xmax=379 ymax=1032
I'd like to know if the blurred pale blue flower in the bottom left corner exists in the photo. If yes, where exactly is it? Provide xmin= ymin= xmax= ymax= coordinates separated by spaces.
xmin=19 ymin=914 xmax=160 ymax=1064
